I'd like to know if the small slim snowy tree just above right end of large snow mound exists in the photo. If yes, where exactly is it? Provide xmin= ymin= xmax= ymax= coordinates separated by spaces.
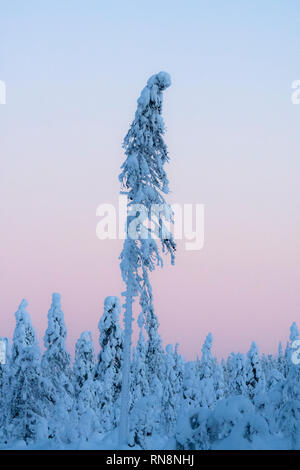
xmin=246 ymin=341 xmax=266 ymax=402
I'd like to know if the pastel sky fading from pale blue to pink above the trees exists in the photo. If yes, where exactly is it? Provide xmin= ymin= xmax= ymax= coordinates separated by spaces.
xmin=0 ymin=0 xmax=300 ymax=359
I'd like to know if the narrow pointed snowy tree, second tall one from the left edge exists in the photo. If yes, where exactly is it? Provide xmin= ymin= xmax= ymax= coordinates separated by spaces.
xmin=42 ymin=293 xmax=75 ymax=442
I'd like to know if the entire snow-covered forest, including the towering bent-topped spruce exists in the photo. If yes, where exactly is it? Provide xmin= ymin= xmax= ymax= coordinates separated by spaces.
xmin=0 ymin=72 xmax=300 ymax=450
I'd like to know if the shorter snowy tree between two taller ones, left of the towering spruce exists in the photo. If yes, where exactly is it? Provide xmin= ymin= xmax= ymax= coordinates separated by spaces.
xmin=74 ymin=331 xmax=100 ymax=440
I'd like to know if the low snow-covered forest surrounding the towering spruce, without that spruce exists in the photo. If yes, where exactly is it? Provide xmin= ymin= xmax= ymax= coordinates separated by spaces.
xmin=0 ymin=294 xmax=300 ymax=449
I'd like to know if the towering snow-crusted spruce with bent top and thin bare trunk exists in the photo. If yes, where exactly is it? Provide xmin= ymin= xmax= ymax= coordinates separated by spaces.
xmin=119 ymin=72 xmax=176 ymax=446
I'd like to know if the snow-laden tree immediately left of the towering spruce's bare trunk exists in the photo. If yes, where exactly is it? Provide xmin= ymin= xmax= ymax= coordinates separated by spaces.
xmin=95 ymin=296 xmax=123 ymax=431
